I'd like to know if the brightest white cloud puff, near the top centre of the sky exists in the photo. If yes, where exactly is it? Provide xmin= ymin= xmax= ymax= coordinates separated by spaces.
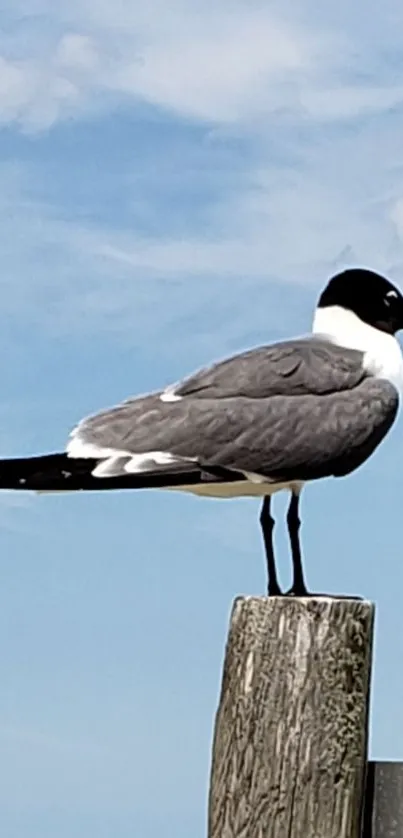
xmin=112 ymin=13 xmax=316 ymax=123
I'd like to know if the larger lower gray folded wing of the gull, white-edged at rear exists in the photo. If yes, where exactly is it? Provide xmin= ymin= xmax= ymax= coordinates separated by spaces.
xmin=68 ymin=378 xmax=398 ymax=483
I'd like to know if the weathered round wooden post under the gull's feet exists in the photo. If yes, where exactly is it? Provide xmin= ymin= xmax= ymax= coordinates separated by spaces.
xmin=208 ymin=597 xmax=374 ymax=838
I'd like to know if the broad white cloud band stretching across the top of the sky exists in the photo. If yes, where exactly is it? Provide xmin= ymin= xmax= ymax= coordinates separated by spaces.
xmin=0 ymin=0 xmax=402 ymax=131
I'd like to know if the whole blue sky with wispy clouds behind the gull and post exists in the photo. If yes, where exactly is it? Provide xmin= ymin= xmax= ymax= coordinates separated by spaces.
xmin=0 ymin=0 xmax=403 ymax=838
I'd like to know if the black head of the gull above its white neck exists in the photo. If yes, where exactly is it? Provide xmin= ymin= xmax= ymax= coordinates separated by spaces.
xmin=318 ymin=268 xmax=403 ymax=335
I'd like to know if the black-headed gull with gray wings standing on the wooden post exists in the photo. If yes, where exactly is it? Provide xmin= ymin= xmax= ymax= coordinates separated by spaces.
xmin=0 ymin=268 xmax=403 ymax=597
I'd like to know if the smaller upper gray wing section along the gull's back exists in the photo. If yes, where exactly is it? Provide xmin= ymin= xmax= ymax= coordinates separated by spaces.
xmin=164 ymin=336 xmax=365 ymax=399
